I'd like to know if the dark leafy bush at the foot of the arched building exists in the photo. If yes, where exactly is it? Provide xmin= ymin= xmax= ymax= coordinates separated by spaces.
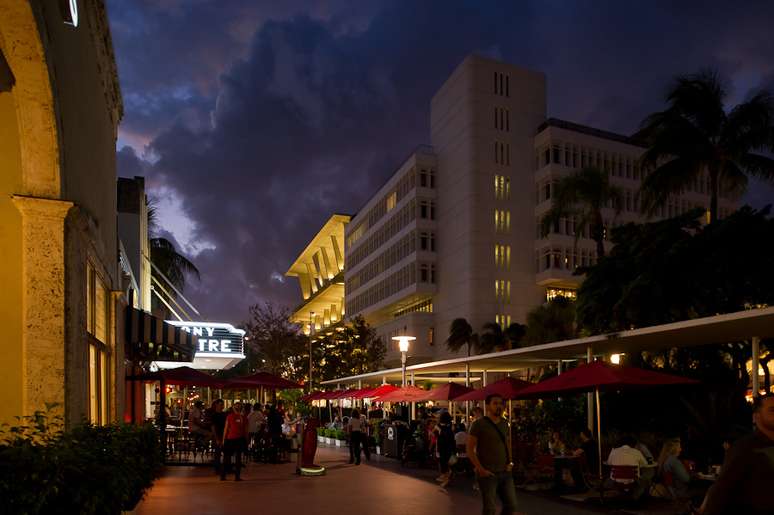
xmin=0 ymin=413 xmax=162 ymax=515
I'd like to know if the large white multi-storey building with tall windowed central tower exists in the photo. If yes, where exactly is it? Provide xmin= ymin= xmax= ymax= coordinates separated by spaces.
xmin=290 ymin=56 xmax=735 ymax=365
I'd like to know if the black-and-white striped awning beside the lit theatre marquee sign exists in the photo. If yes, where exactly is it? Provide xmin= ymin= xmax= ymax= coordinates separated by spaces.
xmin=126 ymin=306 xmax=198 ymax=362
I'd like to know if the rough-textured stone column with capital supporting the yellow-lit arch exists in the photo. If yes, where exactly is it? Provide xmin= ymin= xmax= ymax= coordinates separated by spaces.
xmin=13 ymin=195 xmax=73 ymax=416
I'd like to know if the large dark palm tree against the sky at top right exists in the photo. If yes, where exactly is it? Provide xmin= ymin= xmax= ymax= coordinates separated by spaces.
xmin=635 ymin=71 xmax=774 ymax=223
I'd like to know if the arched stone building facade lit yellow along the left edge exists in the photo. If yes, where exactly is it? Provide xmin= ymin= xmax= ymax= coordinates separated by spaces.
xmin=0 ymin=0 xmax=124 ymax=425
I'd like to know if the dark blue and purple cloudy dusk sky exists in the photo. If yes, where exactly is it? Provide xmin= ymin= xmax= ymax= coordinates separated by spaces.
xmin=107 ymin=0 xmax=774 ymax=323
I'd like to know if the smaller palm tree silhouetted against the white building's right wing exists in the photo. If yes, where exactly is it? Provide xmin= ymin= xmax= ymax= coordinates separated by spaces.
xmin=542 ymin=168 xmax=623 ymax=258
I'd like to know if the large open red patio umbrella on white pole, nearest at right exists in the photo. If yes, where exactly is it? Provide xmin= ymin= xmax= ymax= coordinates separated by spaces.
xmin=516 ymin=361 xmax=698 ymax=480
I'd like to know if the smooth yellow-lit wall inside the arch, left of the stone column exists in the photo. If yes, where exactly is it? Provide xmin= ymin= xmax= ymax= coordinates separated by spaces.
xmin=0 ymin=93 xmax=22 ymax=423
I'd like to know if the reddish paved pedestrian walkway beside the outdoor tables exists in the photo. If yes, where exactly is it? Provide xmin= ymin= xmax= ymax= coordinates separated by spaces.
xmin=136 ymin=448 xmax=598 ymax=515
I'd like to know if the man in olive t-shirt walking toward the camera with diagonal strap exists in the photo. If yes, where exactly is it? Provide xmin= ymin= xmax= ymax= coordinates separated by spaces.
xmin=466 ymin=394 xmax=516 ymax=515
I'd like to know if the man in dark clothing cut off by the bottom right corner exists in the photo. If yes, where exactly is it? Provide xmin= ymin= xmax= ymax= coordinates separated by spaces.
xmin=700 ymin=394 xmax=774 ymax=515
